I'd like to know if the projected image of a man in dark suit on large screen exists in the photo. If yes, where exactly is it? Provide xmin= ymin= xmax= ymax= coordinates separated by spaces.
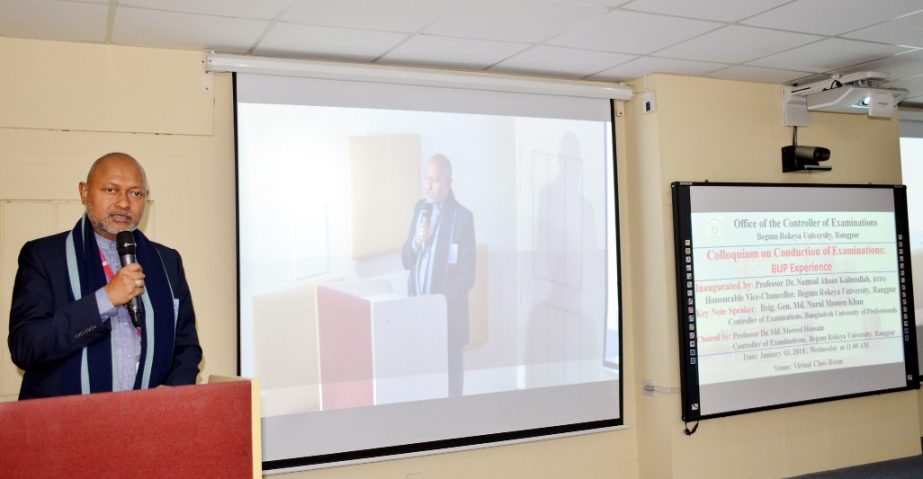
xmin=401 ymin=155 xmax=476 ymax=396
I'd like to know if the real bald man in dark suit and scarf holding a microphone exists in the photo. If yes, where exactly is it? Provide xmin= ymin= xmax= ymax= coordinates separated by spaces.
xmin=8 ymin=153 xmax=202 ymax=399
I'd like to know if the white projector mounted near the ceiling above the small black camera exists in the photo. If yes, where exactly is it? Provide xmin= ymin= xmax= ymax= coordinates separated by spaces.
xmin=782 ymin=72 xmax=907 ymax=126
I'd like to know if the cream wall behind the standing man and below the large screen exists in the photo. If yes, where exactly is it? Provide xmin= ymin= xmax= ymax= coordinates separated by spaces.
xmin=0 ymin=38 xmax=638 ymax=479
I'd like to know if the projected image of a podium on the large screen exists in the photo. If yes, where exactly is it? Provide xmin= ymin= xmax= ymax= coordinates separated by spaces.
xmin=317 ymin=280 xmax=448 ymax=410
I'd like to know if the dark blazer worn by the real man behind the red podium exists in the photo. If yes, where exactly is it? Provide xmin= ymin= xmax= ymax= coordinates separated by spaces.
xmin=9 ymin=232 xmax=202 ymax=399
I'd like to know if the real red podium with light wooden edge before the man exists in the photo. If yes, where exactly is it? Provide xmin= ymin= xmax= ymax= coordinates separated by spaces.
xmin=0 ymin=377 xmax=262 ymax=478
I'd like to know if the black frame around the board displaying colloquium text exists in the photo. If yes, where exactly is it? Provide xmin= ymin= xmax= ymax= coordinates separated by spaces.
xmin=670 ymin=181 xmax=920 ymax=422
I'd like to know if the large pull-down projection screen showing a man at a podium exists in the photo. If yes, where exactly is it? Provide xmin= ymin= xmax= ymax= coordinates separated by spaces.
xmin=235 ymin=74 xmax=622 ymax=471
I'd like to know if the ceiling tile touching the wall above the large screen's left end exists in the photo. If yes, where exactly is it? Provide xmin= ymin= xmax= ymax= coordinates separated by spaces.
xmin=112 ymin=7 xmax=269 ymax=53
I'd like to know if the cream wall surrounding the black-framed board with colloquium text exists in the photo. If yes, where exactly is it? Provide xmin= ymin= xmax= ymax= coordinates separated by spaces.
xmin=624 ymin=75 xmax=920 ymax=478
